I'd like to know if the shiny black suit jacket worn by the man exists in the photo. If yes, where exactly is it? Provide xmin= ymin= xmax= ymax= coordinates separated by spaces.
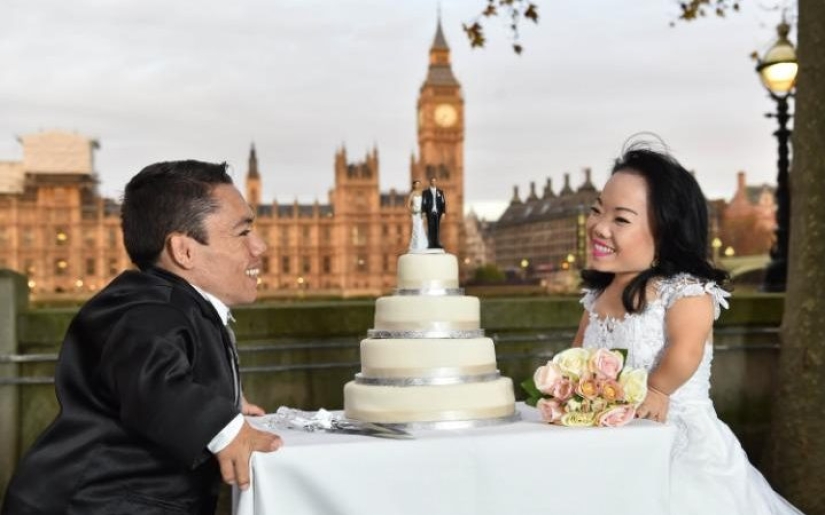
xmin=2 ymin=269 xmax=238 ymax=515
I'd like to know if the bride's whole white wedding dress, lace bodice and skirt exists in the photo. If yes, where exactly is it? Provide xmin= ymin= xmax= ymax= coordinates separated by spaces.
xmin=582 ymin=274 xmax=801 ymax=515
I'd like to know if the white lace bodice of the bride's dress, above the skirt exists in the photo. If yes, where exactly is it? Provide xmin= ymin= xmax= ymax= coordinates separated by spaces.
xmin=581 ymin=274 xmax=730 ymax=404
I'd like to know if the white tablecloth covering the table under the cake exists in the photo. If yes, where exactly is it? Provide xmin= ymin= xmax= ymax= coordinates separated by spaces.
xmin=234 ymin=404 xmax=674 ymax=515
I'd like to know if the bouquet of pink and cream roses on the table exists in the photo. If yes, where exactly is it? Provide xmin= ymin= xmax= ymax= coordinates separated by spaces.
xmin=521 ymin=347 xmax=647 ymax=427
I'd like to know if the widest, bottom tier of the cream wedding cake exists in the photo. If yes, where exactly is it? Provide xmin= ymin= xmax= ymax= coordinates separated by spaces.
xmin=344 ymin=377 xmax=516 ymax=424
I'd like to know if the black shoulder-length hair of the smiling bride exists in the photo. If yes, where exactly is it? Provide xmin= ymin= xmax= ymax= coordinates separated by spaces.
xmin=581 ymin=144 xmax=729 ymax=313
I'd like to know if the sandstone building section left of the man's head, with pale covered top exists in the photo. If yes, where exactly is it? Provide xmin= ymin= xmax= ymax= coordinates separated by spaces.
xmin=0 ymin=131 xmax=129 ymax=295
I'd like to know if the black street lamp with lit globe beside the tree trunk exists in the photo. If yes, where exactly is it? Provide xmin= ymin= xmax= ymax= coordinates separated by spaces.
xmin=756 ymin=18 xmax=799 ymax=292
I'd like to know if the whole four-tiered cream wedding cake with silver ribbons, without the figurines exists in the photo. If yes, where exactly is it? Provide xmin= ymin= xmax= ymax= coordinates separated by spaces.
xmin=344 ymin=252 xmax=517 ymax=427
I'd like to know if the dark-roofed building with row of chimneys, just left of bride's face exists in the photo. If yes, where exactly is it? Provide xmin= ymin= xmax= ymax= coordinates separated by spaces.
xmin=492 ymin=168 xmax=598 ymax=284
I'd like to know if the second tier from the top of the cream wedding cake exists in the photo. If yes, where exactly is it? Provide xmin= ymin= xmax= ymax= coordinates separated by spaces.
xmin=374 ymin=295 xmax=481 ymax=331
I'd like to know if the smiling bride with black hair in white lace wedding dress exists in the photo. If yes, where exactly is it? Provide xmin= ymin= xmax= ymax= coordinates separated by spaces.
xmin=574 ymin=148 xmax=800 ymax=515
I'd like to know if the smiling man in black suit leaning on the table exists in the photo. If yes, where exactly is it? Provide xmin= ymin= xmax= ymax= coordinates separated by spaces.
xmin=2 ymin=161 xmax=281 ymax=515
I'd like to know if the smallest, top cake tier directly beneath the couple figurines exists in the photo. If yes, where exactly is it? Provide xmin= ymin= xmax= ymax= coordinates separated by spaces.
xmin=398 ymin=253 xmax=458 ymax=292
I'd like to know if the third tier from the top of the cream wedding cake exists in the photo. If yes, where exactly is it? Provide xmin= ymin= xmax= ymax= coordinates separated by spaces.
xmin=359 ymin=338 xmax=498 ymax=383
